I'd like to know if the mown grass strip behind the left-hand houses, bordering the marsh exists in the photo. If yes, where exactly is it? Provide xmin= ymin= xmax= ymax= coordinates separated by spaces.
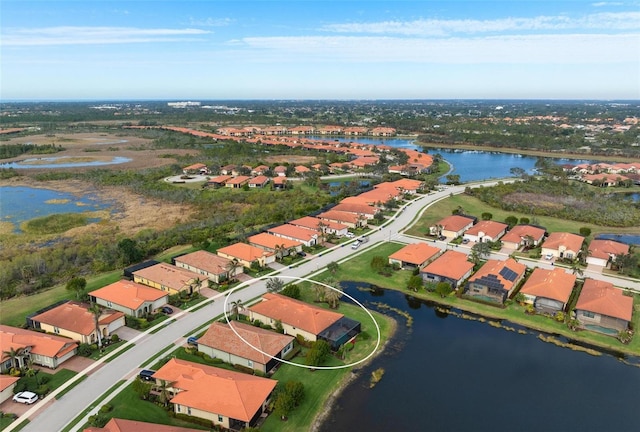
xmin=0 ymin=270 xmax=122 ymax=327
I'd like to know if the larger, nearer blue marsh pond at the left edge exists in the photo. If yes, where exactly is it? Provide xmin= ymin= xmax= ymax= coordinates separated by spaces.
xmin=0 ymin=186 xmax=112 ymax=233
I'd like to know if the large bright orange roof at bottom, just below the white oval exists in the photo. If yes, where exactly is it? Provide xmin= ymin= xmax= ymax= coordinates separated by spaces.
xmin=153 ymin=359 xmax=278 ymax=422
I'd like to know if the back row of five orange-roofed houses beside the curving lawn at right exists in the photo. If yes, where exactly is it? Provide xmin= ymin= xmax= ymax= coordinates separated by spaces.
xmin=430 ymin=215 xmax=629 ymax=267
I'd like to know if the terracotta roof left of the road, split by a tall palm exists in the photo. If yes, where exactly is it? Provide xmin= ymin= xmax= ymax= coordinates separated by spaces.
xmin=32 ymin=302 xmax=124 ymax=336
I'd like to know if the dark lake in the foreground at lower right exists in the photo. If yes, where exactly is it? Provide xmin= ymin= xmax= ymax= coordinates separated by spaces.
xmin=316 ymin=282 xmax=640 ymax=432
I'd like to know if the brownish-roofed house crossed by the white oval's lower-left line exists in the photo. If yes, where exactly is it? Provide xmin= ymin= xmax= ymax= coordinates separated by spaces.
xmin=198 ymin=321 xmax=294 ymax=373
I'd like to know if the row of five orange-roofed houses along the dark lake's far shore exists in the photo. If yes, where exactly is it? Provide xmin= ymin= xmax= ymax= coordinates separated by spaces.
xmin=389 ymin=243 xmax=633 ymax=335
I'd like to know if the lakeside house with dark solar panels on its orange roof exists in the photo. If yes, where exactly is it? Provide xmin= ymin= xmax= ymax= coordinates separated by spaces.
xmin=465 ymin=258 xmax=527 ymax=304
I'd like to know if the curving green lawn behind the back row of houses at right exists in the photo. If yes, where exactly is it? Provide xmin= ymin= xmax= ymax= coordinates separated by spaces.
xmin=406 ymin=194 xmax=638 ymax=238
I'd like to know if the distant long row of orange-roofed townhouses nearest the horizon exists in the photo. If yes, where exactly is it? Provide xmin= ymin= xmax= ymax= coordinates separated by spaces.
xmin=217 ymin=125 xmax=396 ymax=137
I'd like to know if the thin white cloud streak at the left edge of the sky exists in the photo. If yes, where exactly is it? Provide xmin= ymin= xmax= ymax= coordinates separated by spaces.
xmin=0 ymin=27 xmax=209 ymax=46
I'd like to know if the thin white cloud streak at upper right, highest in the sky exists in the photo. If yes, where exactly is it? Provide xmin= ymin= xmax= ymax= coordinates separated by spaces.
xmin=322 ymin=12 xmax=640 ymax=36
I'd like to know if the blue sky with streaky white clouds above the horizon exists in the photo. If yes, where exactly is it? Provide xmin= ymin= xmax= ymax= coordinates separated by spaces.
xmin=0 ymin=0 xmax=640 ymax=100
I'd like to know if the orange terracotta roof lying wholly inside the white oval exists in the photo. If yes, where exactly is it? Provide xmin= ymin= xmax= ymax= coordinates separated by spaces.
xmin=249 ymin=293 xmax=344 ymax=335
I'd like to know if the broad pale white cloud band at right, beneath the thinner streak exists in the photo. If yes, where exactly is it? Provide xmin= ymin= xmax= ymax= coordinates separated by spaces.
xmin=238 ymin=34 xmax=640 ymax=64
